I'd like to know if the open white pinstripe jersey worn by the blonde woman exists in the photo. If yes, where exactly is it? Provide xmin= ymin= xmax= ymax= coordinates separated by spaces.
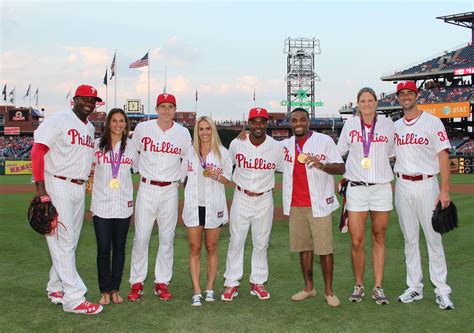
xmin=183 ymin=146 xmax=232 ymax=228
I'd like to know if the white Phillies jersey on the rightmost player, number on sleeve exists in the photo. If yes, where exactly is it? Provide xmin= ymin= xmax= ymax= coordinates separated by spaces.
xmin=394 ymin=112 xmax=451 ymax=175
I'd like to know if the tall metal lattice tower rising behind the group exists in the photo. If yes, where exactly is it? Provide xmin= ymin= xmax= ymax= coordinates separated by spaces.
xmin=283 ymin=37 xmax=321 ymax=118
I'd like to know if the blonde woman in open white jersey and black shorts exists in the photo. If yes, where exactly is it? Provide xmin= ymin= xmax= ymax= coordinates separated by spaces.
xmin=182 ymin=116 xmax=232 ymax=306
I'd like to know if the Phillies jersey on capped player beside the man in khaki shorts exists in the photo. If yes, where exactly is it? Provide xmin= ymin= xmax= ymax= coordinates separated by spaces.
xmin=229 ymin=135 xmax=283 ymax=193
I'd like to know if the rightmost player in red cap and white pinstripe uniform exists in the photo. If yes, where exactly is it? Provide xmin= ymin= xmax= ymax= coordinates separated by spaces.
xmin=394 ymin=81 xmax=454 ymax=310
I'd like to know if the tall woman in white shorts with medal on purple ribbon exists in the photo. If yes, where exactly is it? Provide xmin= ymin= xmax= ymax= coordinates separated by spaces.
xmin=337 ymin=87 xmax=395 ymax=304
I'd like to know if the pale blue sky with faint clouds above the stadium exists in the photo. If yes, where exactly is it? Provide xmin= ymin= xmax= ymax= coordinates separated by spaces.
xmin=0 ymin=0 xmax=474 ymax=120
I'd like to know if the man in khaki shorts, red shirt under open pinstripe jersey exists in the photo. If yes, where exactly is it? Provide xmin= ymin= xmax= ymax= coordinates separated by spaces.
xmin=283 ymin=108 xmax=344 ymax=306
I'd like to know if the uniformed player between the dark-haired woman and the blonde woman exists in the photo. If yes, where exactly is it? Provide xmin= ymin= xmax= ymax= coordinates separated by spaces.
xmin=128 ymin=94 xmax=191 ymax=301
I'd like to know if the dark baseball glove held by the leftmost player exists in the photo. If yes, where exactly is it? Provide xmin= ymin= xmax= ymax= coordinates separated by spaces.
xmin=28 ymin=195 xmax=58 ymax=235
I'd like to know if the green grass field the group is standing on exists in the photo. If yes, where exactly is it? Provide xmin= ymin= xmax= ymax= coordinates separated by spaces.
xmin=0 ymin=175 xmax=474 ymax=332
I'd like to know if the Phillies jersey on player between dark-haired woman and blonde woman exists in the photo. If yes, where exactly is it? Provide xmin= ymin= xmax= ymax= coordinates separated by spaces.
xmin=133 ymin=120 xmax=191 ymax=182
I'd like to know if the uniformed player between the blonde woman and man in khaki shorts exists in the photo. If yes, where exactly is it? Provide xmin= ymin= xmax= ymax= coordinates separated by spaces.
xmin=221 ymin=108 xmax=283 ymax=302
